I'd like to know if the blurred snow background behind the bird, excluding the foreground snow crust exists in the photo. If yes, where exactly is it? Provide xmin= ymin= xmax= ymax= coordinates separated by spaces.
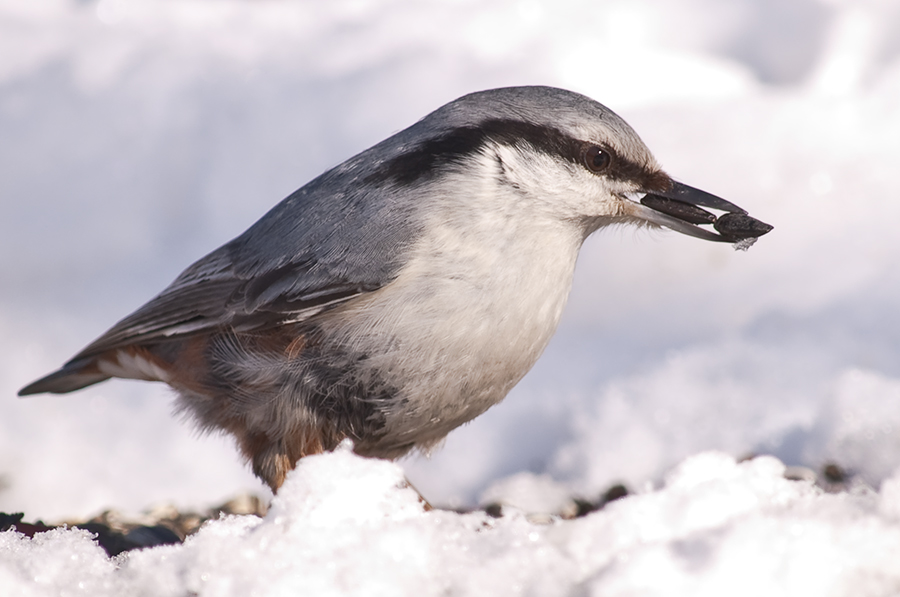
xmin=0 ymin=0 xmax=900 ymax=532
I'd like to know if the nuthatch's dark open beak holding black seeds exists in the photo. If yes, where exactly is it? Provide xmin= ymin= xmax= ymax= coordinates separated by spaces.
xmin=630 ymin=181 xmax=772 ymax=246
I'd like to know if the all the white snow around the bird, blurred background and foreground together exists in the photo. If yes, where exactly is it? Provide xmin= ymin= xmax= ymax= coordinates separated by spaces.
xmin=0 ymin=0 xmax=900 ymax=595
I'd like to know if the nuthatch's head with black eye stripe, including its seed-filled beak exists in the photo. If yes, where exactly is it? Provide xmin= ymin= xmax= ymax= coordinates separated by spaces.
xmin=362 ymin=87 xmax=772 ymax=246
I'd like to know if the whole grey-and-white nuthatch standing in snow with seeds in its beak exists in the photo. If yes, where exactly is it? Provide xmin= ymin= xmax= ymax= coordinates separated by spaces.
xmin=19 ymin=86 xmax=772 ymax=491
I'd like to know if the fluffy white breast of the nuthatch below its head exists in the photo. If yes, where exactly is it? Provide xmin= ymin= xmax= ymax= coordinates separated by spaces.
xmin=326 ymin=154 xmax=583 ymax=444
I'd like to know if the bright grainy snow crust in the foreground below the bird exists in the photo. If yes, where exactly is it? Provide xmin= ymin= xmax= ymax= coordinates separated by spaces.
xmin=0 ymin=448 xmax=900 ymax=597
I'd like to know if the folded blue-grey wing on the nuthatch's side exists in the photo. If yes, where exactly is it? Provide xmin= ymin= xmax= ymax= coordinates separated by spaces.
xmin=70 ymin=160 xmax=417 ymax=362
